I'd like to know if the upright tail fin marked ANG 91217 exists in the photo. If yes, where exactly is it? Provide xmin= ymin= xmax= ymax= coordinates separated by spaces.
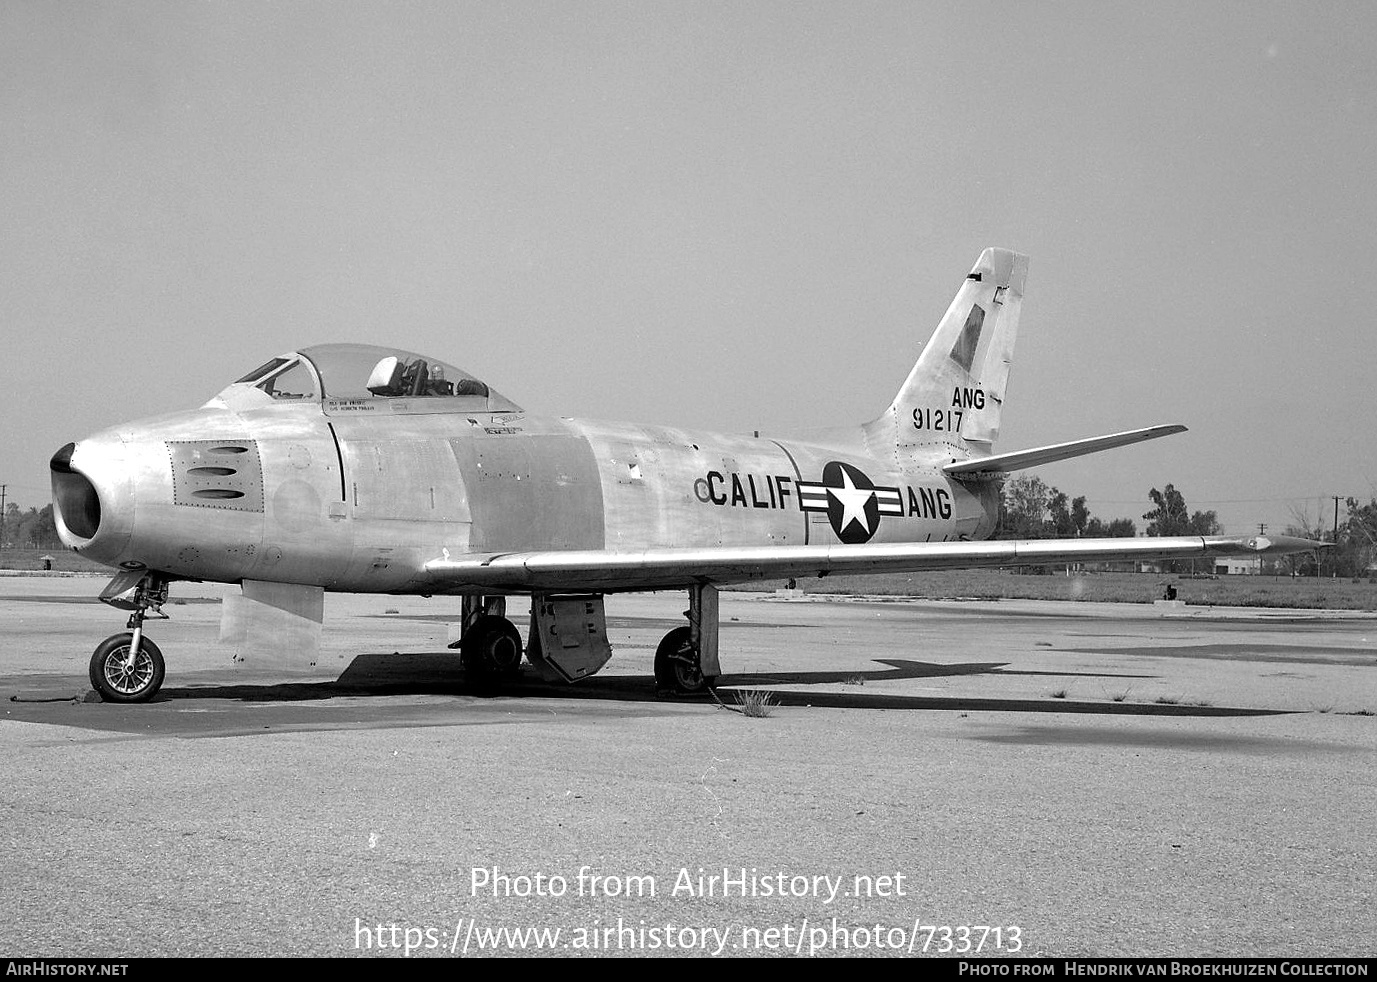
xmin=866 ymin=249 xmax=1029 ymax=457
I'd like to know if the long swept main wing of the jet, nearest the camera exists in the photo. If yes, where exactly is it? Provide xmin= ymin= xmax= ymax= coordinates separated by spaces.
xmin=424 ymin=536 xmax=1323 ymax=594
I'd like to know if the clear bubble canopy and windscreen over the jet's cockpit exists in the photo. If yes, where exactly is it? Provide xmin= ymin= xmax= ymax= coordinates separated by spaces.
xmin=227 ymin=344 xmax=518 ymax=412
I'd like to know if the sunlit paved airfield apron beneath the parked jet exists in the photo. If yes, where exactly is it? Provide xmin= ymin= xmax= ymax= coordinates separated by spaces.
xmin=0 ymin=577 xmax=1377 ymax=956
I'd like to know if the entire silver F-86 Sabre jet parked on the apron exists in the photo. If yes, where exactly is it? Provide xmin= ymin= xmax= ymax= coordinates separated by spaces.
xmin=51 ymin=249 xmax=1316 ymax=702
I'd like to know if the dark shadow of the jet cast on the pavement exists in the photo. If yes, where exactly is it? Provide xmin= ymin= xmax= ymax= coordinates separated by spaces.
xmin=158 ymin=653 xmax=1276 ymax=716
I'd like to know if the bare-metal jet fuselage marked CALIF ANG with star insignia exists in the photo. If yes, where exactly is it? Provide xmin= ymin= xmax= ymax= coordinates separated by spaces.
xmin=59 ymin=399 xmax=997 ymax=592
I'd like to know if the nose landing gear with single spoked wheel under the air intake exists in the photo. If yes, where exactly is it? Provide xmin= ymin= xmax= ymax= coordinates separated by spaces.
xmin=91 ymin=572 xmax=168 ymax=702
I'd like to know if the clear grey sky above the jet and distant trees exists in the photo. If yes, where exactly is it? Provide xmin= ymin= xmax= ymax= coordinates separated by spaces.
xmin=0 ymin=0 xmax=1377 ymax=534
